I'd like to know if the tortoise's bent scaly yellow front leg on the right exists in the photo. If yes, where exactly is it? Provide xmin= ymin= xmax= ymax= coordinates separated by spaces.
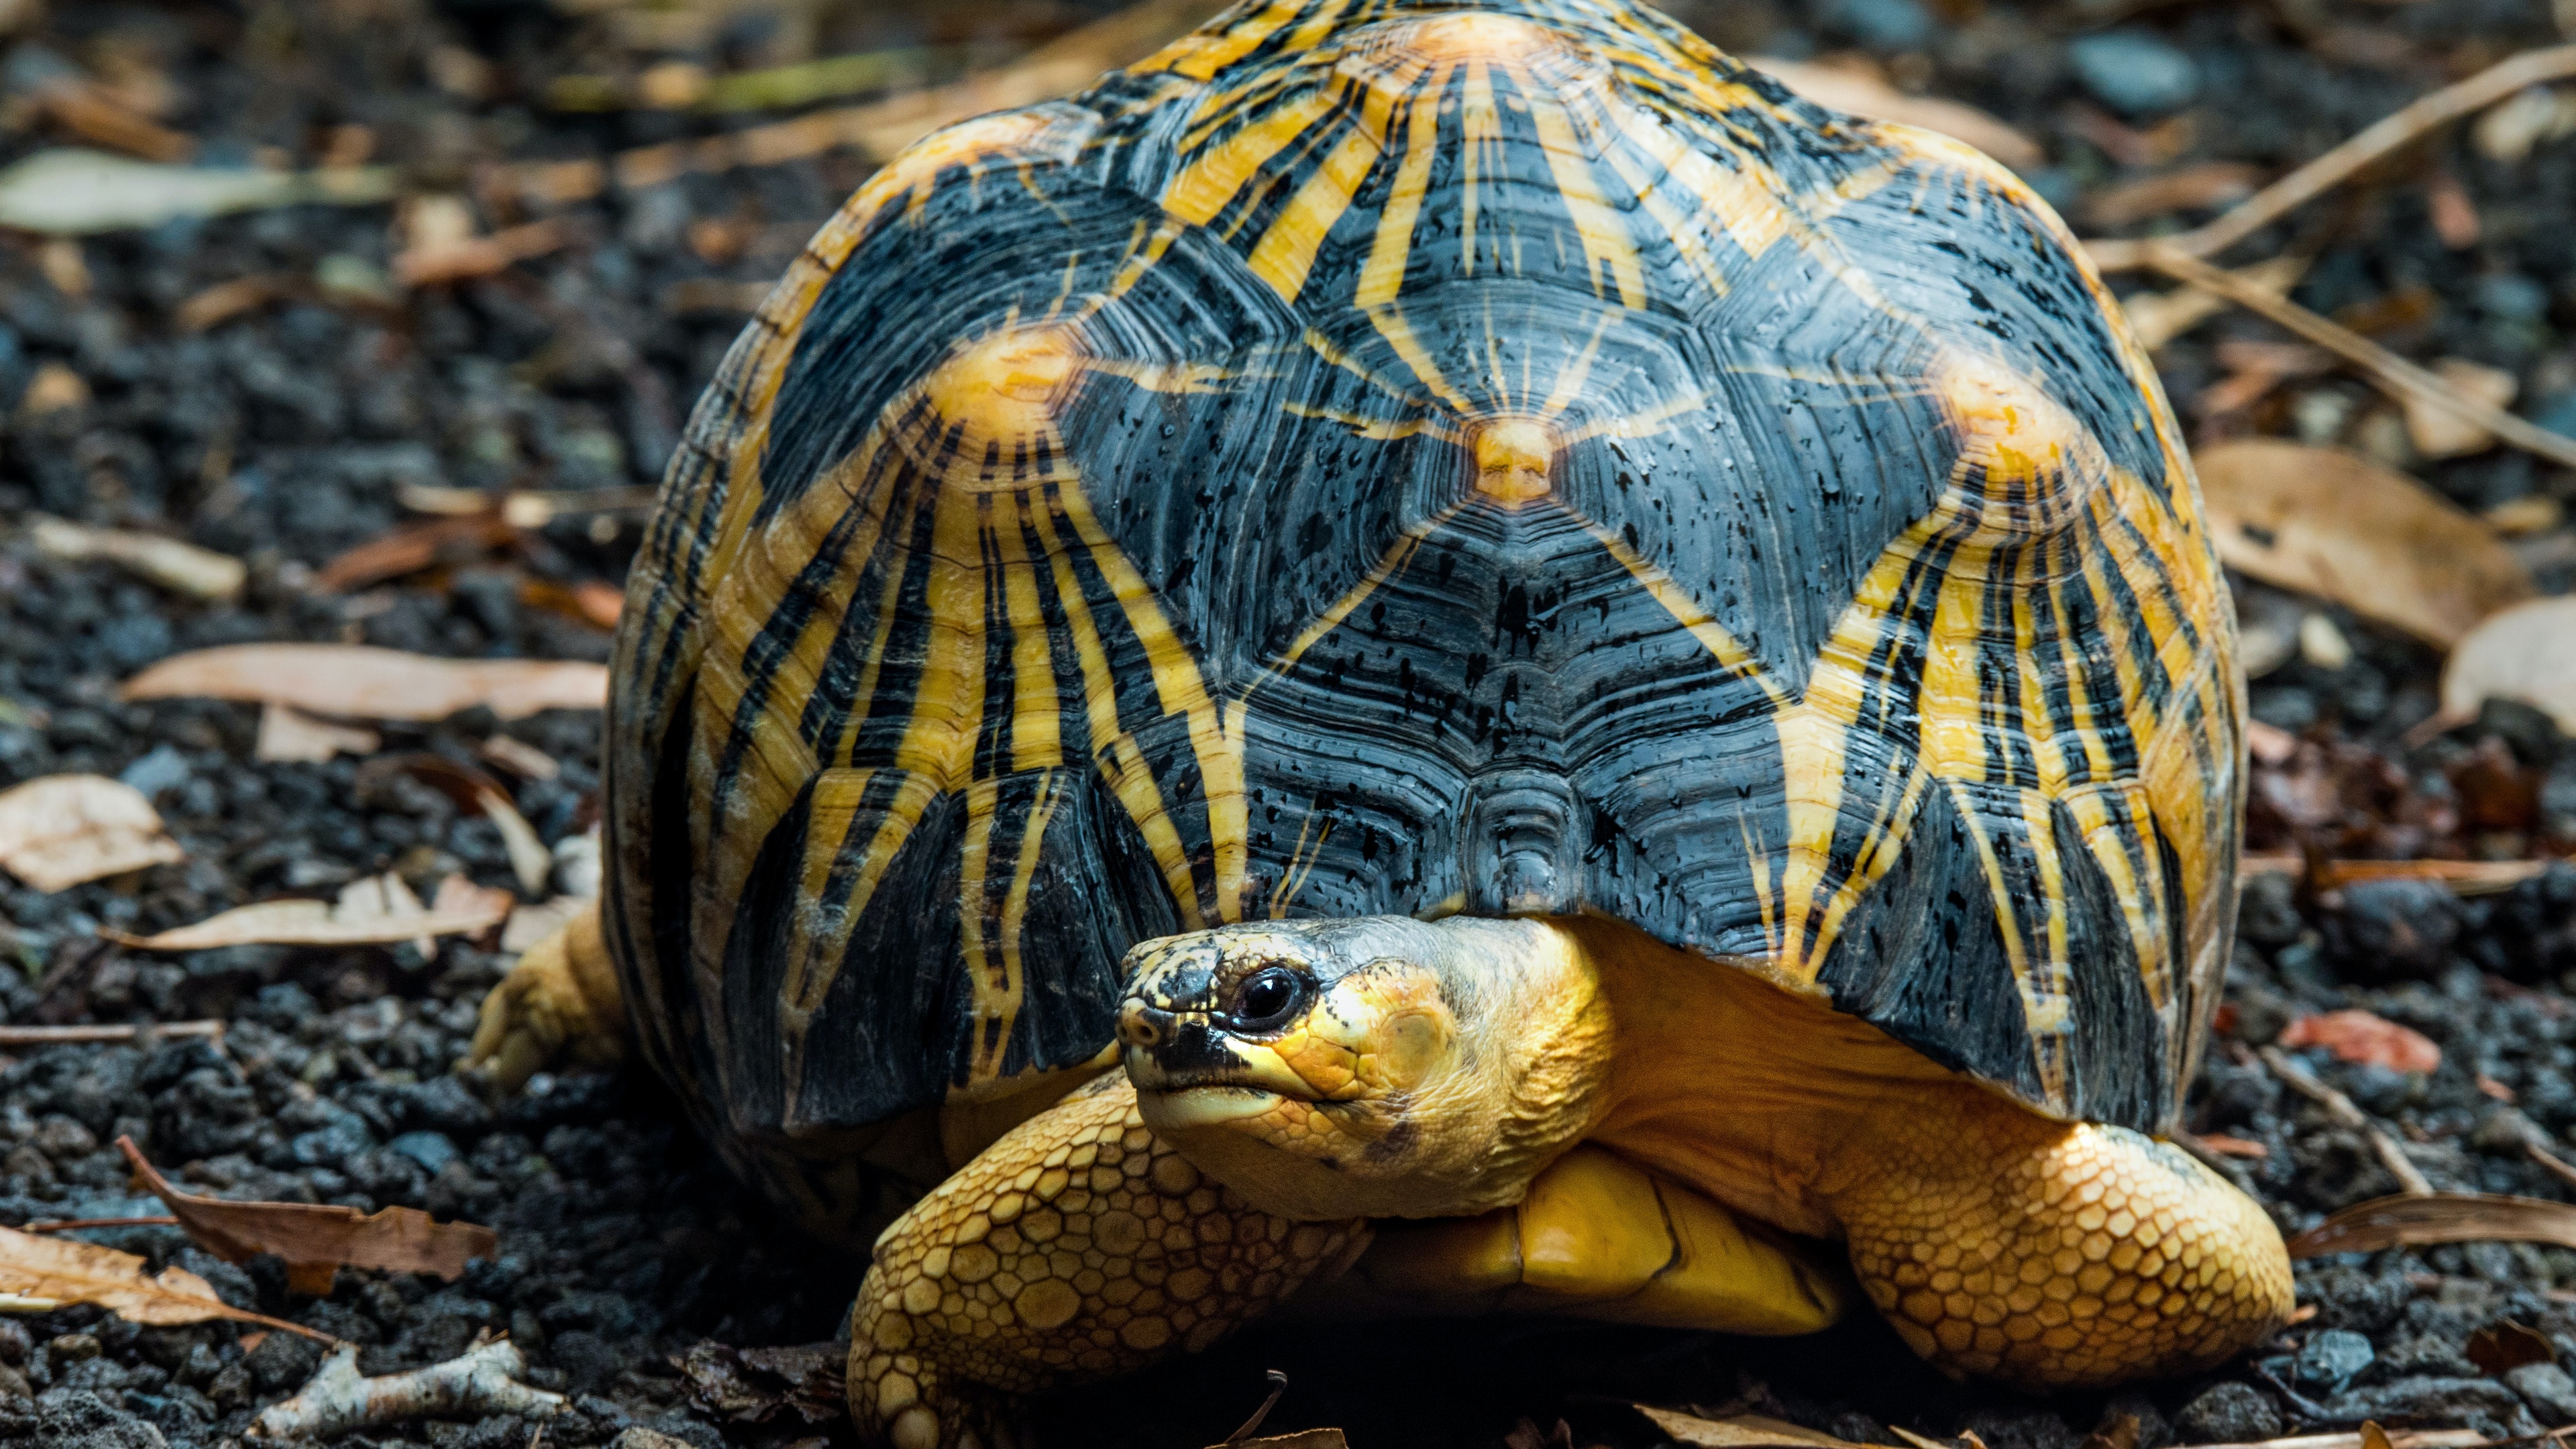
xmin=1834 ymin=1085 xmax=2290 ymax=1390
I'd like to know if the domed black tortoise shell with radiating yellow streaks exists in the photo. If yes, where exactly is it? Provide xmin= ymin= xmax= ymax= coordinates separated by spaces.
xmin=608 ymin=0 xmax=2241 ymax=1217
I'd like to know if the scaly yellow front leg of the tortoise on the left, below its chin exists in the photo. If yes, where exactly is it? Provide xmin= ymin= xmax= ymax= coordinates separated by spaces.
xmin=850 ymin=1073 xmax=1368 ymax=1449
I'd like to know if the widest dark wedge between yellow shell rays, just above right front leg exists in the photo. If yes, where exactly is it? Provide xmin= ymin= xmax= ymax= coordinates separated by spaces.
xmin=1819 ymin=786 xmax=2040 ymax=1098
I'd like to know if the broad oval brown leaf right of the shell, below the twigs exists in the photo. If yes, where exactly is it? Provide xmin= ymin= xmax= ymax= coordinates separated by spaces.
xmin=2195 ymin=438 xmax=2532 ymax=647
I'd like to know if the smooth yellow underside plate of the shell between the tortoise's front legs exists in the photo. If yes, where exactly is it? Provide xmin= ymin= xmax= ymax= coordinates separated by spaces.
xmin=1293 ymin=1142 xmax=1844 ymax=1336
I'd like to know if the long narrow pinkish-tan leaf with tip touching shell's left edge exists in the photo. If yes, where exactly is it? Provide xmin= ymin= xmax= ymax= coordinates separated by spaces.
xmin=119 ymin=645 xmax=608 ymax=722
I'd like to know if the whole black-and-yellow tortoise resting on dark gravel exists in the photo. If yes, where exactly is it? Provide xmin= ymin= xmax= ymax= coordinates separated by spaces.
xmin=476 ymin=0 xmax=2290 ymax=1449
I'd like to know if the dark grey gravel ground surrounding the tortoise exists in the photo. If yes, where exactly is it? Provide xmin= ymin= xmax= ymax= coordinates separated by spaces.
xmin=0 ymin=0 xmax=2576 ymax=1449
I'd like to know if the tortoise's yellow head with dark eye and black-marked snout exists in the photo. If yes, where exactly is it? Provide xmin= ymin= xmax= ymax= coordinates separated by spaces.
xmin=1118 ymin=915 xmax=1607 ymax=1220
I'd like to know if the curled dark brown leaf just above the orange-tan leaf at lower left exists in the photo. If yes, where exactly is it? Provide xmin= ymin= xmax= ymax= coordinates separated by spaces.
xmin=116 ymin=1137 xmax=500 ymax=1294
